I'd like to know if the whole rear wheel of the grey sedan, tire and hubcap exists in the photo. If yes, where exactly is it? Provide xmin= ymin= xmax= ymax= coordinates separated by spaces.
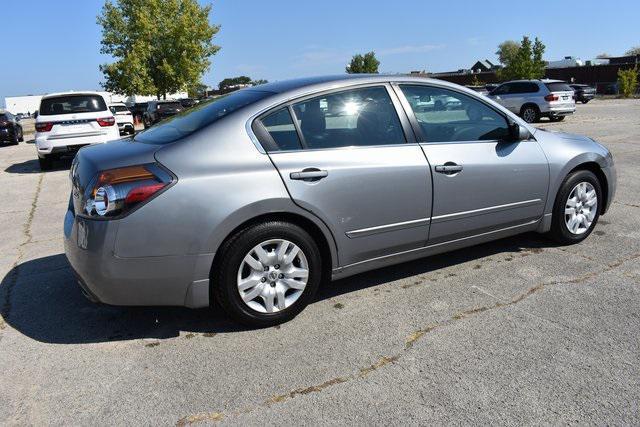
xmin=211 ymin=221 xmax=322 ymax=327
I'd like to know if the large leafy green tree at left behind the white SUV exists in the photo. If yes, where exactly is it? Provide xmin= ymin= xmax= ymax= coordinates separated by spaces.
xmin=97 ymin=0 xmax=220 ymax=98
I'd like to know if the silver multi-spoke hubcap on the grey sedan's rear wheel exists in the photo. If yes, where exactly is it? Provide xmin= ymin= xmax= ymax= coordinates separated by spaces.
xmin=237 ymin=239 xmax=309 ymax=313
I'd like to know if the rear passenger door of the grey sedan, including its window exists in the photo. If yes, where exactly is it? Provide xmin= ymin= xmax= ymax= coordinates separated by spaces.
xmin=254 ymin=85 xmax=432 ymax=266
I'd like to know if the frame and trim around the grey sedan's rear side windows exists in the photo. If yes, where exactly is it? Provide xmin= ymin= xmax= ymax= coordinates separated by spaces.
xmin=254 ymin=82 xmax=410 ymax=153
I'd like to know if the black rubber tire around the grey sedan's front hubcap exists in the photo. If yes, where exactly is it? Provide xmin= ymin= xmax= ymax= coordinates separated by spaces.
xmin=548 ymin=170 xmax=603 ymax=245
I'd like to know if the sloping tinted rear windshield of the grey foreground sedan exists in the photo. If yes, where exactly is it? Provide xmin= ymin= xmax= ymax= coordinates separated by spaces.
xmin=134 ymin=90 xmax=273 ymax=144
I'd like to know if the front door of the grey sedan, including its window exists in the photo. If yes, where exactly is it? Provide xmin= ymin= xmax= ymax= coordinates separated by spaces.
xmin=398 ymin=84 xmax=549 ymax=244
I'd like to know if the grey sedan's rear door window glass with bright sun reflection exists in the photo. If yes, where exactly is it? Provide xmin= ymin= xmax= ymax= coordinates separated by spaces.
xmin=293 ymin=86 xmax=406 ymax=149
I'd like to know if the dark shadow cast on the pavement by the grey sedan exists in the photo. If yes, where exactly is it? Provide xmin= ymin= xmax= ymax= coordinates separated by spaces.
xmin=0 ymin=234 xmax=553 ymax=344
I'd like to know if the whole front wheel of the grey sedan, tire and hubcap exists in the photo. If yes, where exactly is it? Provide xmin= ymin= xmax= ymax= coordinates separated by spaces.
xmin=549 ymin=170 xmax=602 ymax=244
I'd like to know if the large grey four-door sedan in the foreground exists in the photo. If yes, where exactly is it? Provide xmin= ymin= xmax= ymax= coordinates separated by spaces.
xmin=64 ymin=75 xmax=616 ymax=326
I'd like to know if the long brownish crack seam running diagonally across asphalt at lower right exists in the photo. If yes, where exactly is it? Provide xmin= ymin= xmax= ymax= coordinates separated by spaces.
xmin=176 ymin=252 xmax=640 ymax=427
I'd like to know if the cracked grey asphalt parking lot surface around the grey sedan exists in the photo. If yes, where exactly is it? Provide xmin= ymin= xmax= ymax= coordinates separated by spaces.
xmin=0 ymin=100 xmax=640 ymax=425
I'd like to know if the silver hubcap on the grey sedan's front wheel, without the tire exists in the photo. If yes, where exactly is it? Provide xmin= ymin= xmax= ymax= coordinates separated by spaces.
xmin=564 ymin=182 xmax=598 ymax=234
